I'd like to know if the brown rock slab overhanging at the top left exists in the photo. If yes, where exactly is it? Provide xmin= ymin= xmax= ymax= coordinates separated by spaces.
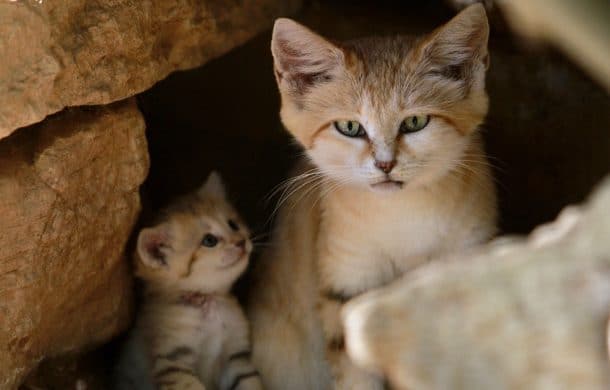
xmin=0 ymin=0 xmax=300 ymax=138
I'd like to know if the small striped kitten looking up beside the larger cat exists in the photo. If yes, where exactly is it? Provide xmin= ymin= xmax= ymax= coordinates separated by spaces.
xmin=119 ymin=173 xmax=262 ymax=390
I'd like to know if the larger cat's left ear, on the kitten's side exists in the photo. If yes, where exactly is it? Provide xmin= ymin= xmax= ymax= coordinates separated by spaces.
xmin=271 ymin=18 xmax=344 ymax=95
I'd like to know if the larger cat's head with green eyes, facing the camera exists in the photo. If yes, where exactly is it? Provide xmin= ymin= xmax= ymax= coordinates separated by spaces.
xmin=271 ymin=5 xmax=488 ymax=190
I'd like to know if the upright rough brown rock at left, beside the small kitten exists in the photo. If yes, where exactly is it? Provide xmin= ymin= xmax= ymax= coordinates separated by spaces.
xmin=0 ymin=100 xmax=148 ymax=389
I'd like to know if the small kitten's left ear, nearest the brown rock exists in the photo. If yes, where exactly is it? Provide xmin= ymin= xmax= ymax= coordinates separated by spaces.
xmin=137 ymin=223 xmax=172 ymax=268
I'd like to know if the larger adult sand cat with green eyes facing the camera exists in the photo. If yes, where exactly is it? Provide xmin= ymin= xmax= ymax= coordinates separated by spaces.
xmin=248 ymin=5 xmax=496 ymax=390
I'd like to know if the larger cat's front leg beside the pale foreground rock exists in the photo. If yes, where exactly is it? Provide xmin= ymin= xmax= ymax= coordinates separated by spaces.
xmin=318 ymin=289 xmax=384 ymax=390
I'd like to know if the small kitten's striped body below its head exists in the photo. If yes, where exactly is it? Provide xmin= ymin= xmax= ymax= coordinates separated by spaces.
xmin=119 ymin=294 xmax=261 ymax=390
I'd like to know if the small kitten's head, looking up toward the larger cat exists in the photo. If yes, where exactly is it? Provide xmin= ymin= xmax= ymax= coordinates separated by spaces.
xmin=136 ymin=172 xmax=252 ymax=292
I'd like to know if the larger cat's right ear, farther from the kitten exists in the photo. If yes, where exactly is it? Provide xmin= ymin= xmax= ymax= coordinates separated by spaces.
xmin=422 ymin=3 xmax=489 ymax=81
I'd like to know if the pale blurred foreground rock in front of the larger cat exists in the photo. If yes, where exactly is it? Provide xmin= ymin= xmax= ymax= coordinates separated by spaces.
xmin=343 ymin=178 xmax=610 ymax=389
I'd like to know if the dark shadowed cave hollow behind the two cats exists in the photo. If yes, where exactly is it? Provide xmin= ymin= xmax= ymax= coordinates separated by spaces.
xmin=21 ymin=0 xmax=610 ymax=388
